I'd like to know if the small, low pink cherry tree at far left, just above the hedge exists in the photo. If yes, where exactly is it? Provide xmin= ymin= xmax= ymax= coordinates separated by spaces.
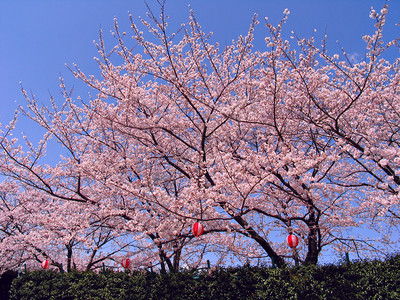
xmin=0 ymin=177 xmax=138 ymax=272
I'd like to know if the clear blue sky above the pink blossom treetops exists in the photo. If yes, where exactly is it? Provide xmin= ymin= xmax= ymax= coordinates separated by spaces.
xmin=0 ymin=0 xmax=400 ymax=124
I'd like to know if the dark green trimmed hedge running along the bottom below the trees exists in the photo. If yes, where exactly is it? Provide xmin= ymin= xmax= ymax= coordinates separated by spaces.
xmin=5 ymin=256 xmax=400 ymax=300
